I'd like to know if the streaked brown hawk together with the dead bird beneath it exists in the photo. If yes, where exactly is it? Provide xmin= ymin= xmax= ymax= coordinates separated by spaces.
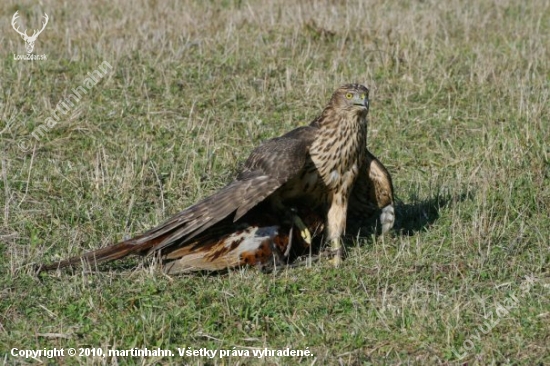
xmin=39 ymin=84 xmax=394 ymax=274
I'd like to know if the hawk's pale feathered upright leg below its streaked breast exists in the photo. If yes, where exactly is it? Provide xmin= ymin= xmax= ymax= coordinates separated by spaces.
xmin=327 ymin=193 xmax=348 ymax=267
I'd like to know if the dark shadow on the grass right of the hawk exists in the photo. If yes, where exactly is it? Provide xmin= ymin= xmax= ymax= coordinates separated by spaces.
xmin=393 ymin=191 xmax=475 ymax=236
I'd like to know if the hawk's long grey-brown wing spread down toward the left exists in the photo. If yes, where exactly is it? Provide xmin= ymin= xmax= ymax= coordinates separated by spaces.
xmin=135 ymin=126 xmax=317 ymax=251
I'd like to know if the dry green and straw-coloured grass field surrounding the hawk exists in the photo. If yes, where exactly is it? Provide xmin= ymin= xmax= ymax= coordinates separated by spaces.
xmin=0 ymin=0 xmax=550 ymax=365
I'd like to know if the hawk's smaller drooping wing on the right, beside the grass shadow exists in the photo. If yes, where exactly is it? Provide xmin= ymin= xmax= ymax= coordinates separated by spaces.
xmin=347 ymin=149 xmax=395 ymax=235
